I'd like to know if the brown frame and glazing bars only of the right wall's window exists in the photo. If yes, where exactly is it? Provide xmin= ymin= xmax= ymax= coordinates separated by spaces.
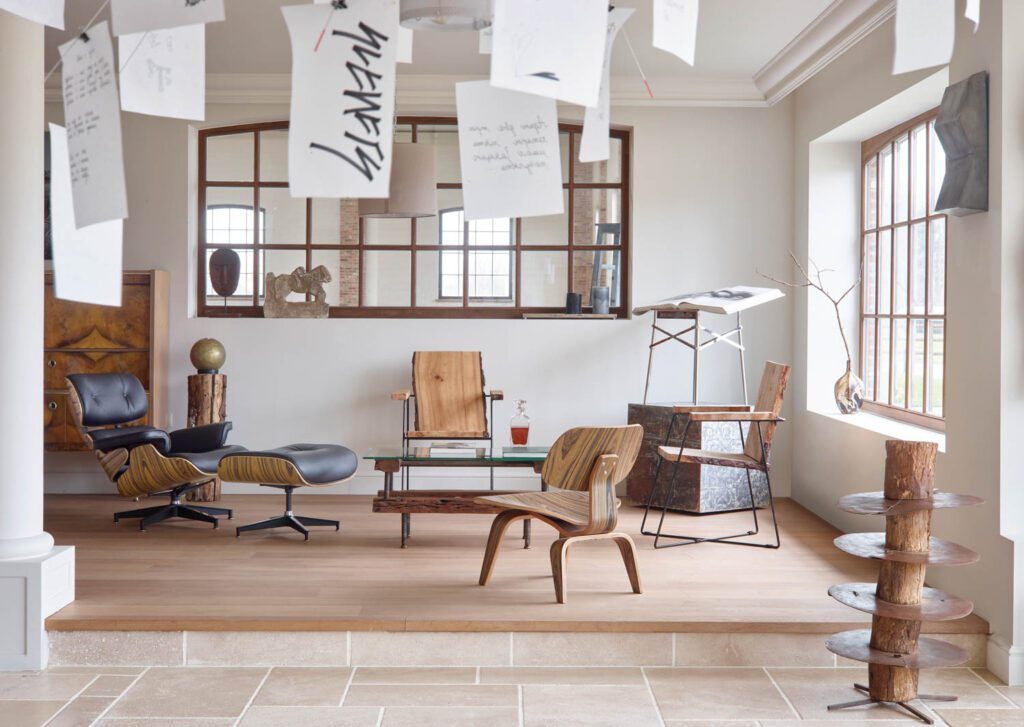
xmin=857 ymin=108 xmax=949 ymax=431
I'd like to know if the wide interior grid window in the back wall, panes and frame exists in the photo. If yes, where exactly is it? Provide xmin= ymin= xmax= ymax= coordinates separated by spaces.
xmin=197 ymin=117 xmax=631 ymax=317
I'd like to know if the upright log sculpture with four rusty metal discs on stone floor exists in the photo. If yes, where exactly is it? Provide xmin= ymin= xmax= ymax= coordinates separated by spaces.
xmin=826 ymin=440 xmax=982 ymax=724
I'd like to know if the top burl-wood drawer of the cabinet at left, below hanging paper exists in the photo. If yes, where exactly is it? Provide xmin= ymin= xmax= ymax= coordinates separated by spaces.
xmin=43 ymin=285 xmax=151 ymax=348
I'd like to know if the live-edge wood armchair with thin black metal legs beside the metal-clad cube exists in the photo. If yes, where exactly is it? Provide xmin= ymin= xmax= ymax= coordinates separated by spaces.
xmin=640 ymin=361 xmax=791 ymax=549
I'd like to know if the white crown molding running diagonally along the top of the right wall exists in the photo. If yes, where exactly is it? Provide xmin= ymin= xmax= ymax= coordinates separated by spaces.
xmin=754 ymin=0 xmax=896 ymax=105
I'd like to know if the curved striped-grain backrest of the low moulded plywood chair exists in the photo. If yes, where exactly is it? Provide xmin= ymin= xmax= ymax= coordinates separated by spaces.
xmin=541 ymin=424 xmax=643 ymax=489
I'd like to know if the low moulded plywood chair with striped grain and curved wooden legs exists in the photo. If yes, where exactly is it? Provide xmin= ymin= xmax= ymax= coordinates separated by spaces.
xmin=477 ymin=424 xmax=643 ymax=603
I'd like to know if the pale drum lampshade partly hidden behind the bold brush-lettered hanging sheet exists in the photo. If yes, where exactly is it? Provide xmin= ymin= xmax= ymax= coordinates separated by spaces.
xmin=359 ymin=143 xmax=437 ymax=217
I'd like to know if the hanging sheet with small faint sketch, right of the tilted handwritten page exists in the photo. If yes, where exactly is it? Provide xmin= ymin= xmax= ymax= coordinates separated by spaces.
xmin=118 ymin=24 xmax=206 ymax=120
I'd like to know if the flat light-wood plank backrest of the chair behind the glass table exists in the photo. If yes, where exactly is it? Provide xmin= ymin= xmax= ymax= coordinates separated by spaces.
xmin=413 ymin=351 xmax=487 ymax=437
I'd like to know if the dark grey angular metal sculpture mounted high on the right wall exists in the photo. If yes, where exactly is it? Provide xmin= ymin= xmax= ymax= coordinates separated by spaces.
xmin=935 ymin=71 xmax=988 ymax=217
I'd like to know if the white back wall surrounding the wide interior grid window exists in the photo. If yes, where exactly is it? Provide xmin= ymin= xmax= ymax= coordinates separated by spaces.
xmin=46 ymin=102 xmax=793 ymax=495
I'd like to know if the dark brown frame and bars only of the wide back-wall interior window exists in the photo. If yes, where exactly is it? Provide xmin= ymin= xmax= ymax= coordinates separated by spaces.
xmin=196 ymin=116 xmax=633 ymax=318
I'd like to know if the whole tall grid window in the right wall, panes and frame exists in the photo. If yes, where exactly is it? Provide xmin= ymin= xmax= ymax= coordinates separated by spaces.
xmin=860 ymin=111 xmax=946 ymax=429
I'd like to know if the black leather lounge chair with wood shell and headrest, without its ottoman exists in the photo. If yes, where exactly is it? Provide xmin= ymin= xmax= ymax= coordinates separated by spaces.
xmin=68 ymin=374 xmax=245 ymax=530
